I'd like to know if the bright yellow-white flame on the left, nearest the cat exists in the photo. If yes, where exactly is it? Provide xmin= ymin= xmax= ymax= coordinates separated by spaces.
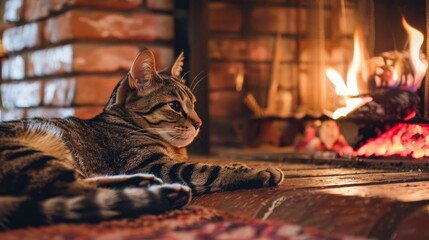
xmin=326 ymin=32 xmax=372 ymax=119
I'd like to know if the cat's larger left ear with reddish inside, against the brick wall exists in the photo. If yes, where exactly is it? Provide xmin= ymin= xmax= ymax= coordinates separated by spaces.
xmin=129 ymin=48 xmax=159 ymax=91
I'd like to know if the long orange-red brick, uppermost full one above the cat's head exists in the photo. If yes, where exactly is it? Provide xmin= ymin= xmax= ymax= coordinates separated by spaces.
xmin=45 ymin=10 xmax=174 ymax=43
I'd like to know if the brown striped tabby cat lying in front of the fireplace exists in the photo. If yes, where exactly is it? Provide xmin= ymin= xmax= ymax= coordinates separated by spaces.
xmin=0 ymin=49 xmax=284 ymax=229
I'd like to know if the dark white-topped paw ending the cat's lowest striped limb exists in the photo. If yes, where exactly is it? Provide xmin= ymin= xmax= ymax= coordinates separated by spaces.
xmin=149 ymin=183 xmax=192 ymax=210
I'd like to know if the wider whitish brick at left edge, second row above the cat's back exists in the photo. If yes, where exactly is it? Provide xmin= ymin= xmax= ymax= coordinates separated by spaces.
xmin=1 ymin=81 xmax=43 ymax=108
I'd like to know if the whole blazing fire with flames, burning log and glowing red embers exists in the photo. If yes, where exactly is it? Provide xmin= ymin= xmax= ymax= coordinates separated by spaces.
xmin=326 ymin=18 xmax=429 ymax=158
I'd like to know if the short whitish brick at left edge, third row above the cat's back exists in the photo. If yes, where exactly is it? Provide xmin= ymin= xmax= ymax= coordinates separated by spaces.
xmin=1 ymin=54 xmax=26 ymax=80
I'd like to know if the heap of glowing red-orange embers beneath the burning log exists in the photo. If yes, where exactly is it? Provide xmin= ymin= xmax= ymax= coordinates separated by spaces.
xmin=354 ymin=123 xmax=429 ymax=158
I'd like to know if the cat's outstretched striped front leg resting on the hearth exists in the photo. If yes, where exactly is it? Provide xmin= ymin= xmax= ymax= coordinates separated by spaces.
xmin=128 ymin=157 xmax=284 ymax=194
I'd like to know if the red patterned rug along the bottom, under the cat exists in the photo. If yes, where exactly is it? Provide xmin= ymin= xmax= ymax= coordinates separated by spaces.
xmin=0 ymin=206 xmax=357 ymax=240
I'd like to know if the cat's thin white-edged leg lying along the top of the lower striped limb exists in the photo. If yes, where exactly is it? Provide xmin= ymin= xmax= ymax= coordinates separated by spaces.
xmin=82 ymin=173 xmax=164 ymax=188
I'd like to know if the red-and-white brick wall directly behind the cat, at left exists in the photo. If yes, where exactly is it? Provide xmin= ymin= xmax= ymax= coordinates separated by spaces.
xmin=0 ymin=0 xmax=174 ymax=120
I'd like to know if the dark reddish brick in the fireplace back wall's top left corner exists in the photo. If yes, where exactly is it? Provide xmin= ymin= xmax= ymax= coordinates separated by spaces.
xmin=208 ymin=3 xmax=243 ymax=31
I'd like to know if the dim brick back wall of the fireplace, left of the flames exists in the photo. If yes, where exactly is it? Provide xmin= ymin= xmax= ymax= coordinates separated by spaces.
xmin=208 ymin=0 xmax=365 ymax=146
